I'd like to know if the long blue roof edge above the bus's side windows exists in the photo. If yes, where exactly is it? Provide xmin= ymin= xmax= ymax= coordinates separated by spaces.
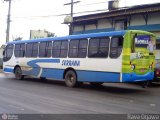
xmin=7 ymin=30 xmax=126 ymax=44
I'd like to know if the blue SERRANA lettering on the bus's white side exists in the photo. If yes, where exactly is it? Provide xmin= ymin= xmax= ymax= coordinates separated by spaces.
xmin=62 ymin=60 xmax=80 ymax=66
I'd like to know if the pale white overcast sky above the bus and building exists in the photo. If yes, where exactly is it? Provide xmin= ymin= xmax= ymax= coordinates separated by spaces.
xmin=0 ymin=0 xmax=160 ymax=45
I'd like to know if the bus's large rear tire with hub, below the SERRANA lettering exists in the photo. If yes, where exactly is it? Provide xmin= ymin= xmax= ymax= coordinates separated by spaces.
xmin=65 ymin=70 xmax=77 ymax=88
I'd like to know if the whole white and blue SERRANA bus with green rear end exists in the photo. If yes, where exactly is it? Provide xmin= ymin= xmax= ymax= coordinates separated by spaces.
xmin=3 ymin=30 xmax=156 ymax=87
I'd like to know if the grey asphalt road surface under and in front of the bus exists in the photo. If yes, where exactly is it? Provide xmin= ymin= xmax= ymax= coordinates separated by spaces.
xmin=0 ymin=73 xmax=160 ymax=114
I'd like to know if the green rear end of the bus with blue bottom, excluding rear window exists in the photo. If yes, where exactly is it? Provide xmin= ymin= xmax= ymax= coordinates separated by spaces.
xmin=122 ymin=31 xmax=155 ymax=82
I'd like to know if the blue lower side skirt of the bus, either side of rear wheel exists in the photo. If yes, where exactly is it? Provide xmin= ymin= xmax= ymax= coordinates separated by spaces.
xmin=41 ymin=68 xmax=120 ymax=82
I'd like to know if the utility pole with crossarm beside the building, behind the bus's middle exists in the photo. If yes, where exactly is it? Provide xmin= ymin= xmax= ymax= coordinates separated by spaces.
xmin=64 ymin=0 xmax=80 ymax=35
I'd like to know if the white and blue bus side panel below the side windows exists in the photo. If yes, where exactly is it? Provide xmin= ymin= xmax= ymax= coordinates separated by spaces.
xmin=4 ymin=56 xmax=122 ymax=82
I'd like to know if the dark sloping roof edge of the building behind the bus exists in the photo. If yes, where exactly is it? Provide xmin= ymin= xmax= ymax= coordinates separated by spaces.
xmin=73 ymin=3 xmax=160 ymax=24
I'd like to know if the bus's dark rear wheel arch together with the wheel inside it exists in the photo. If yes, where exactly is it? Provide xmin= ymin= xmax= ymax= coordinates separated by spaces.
xmin=63 ymin=68 xmax=77 ymax=88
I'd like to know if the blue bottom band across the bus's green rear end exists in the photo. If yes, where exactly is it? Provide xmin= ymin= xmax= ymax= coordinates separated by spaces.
xmin=122 ymin=72 xmax=154 ymax=82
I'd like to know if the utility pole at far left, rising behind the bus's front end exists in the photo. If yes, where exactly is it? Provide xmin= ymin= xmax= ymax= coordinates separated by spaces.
xmin=4 ymin=0 xmax=12 ymax=43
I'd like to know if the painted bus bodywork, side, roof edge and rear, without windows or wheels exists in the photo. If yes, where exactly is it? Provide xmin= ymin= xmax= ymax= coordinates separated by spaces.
xmin=3 ymin=31 xmax=154 ymax=82
